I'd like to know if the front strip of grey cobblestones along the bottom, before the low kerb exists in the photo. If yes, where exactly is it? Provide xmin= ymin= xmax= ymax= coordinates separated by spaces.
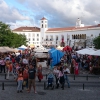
xmin=0 ymin=87 xmax=100 ymax=100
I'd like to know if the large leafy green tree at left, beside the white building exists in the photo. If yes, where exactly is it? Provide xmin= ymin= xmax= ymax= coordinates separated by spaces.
xmin=0 ymin=22 xmax=27 ymax=48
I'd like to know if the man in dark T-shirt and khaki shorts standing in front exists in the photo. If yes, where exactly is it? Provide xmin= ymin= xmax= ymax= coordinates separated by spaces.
xmin=28 ymin=65 xmax=37 ymax=93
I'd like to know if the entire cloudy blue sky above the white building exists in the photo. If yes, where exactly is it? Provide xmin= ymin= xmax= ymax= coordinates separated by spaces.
xmin=0 ymin=0 xmax=100 ymax=29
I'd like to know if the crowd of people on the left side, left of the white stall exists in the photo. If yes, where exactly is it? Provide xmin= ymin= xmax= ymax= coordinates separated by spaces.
xmin=0 ymin=53 xmax=38 ymax=93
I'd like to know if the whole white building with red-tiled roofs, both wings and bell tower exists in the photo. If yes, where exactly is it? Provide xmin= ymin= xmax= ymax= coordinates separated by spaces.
xmin=13 ymin=17 xmax=100 ymax=47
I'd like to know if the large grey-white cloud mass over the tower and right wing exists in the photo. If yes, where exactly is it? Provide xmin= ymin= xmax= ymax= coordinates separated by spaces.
xmin=18 ymin=0 xmax=100 ymax=27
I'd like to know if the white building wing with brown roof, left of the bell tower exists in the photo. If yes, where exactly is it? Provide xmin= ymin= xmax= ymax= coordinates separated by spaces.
xmin=13 ymin=26 xmax=41 ymax=47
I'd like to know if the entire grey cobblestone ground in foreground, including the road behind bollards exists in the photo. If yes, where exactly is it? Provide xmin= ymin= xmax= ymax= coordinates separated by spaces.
xmin=0 ymin=69 xmax=100 ymax=100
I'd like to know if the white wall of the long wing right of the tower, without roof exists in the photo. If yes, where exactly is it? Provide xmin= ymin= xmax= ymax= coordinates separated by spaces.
xmin=44 ymin=27 xmax=100 ymax=46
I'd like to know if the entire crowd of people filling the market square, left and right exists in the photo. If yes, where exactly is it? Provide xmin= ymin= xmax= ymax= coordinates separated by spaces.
xmin=0 ymin=47 xmax=100 ymax=93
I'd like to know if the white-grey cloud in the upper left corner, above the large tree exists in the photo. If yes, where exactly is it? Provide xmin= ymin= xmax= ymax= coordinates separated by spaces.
xmin=0 ymin=0 xmax=30 ymax=23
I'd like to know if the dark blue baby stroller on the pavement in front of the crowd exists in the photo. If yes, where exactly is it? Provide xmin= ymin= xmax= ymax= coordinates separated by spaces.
xmin=44 ymin=73 xmax=54 ymax=90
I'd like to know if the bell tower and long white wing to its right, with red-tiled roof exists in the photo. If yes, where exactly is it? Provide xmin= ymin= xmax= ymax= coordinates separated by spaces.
xmin=41 ymin=18 xmax=100 ymax=47
